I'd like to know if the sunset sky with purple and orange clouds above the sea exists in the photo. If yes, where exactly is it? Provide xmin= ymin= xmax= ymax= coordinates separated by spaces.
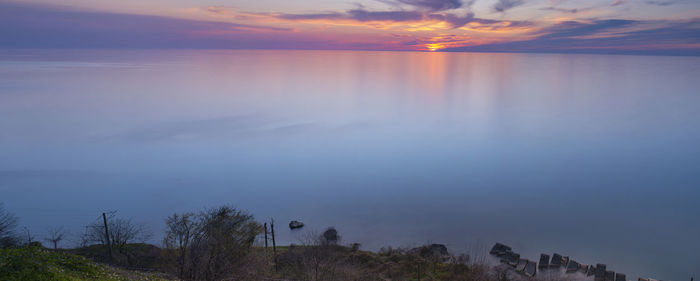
xmin=0 ymin=0 xmax=700 ymax=55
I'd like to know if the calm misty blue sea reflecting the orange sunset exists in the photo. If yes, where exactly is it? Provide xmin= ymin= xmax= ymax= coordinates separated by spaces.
xmin=0 ymin=50 xmax=700 ymax=280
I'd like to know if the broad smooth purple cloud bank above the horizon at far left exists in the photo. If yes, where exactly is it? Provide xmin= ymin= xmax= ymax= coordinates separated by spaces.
xmin=0 ymin=2 xmax=303 ymax=48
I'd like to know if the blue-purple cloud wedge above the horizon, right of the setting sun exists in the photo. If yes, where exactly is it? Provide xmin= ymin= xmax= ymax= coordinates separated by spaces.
xmin=445 ymin=19 xmax=700 ymax=56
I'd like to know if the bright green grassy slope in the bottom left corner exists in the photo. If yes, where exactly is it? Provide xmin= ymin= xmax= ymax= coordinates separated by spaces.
xmin=0 ymin=246 xmax=170 ymax=281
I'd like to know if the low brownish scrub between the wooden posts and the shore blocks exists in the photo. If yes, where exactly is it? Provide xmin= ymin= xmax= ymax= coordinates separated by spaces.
xmin=273 ymin=240 xmax=497 ymax=281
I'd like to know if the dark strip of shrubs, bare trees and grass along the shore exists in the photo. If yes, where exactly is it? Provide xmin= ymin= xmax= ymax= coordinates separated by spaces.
xmin=0 ymin=202 xmax=508 ymax=281
